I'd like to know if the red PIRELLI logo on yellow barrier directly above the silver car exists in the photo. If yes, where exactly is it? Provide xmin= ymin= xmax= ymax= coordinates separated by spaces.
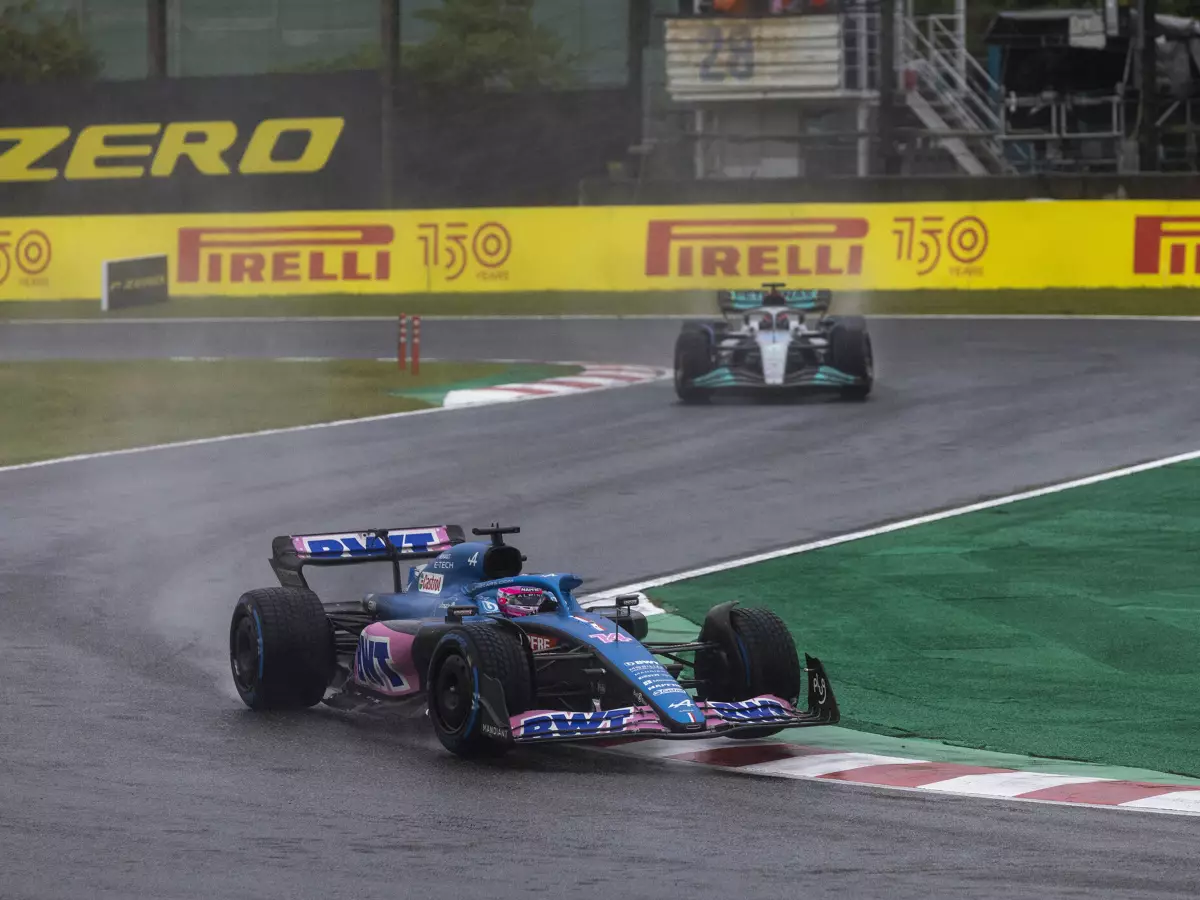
xmin=646 ymin=217 xmax=870 ymax=278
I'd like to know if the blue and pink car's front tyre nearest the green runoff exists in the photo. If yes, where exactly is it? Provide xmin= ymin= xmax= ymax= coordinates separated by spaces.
xmin=696 ymin=608 xmax=803 ymax=740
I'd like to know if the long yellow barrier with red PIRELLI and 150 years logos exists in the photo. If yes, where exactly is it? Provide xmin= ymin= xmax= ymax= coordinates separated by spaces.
xmin=7 ymin=200 xmax=1200 ymax=300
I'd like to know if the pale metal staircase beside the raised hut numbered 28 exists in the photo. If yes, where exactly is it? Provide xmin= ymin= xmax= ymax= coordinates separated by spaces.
xmin=896 ymin=16 xmax=1015 ymax=175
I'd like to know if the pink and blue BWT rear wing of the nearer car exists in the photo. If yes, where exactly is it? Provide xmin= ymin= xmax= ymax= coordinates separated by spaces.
xmin=271 ymin=526 xmax=466 ymax=593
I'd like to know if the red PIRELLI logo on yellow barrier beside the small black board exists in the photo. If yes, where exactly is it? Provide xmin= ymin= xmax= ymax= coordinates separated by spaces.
xmin=179 ymin=224 xmax=396 ymax=284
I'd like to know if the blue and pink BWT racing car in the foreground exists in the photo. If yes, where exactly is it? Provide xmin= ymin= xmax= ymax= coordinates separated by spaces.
xmin=229 ymin=526 xmax=839 ymax=756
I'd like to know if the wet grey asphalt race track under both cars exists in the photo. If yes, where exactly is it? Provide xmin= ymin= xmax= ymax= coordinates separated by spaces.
xmin=7 ymin=322 xmax=1200 ymax=900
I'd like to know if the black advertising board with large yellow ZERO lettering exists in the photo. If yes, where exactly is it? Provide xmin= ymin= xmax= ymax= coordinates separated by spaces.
xmin=0 ymin=72 xmax=380 ymax=215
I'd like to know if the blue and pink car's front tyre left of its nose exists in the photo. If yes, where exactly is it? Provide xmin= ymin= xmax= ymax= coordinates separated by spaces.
xmin=426 ymin=622 xmax=533 ymax=757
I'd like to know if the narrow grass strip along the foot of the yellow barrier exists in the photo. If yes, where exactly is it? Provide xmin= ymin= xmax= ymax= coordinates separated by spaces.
xmin=7 ymin=288 xmax=1200 ymax=320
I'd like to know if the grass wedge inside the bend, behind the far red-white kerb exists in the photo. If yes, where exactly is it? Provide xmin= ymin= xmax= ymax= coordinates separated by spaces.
xmin=0 ymin=360 xmax=580 ymax=464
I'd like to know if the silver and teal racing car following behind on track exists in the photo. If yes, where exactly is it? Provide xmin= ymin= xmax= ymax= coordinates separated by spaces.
xmin=674 ymin=284 xmax=875 ymax=403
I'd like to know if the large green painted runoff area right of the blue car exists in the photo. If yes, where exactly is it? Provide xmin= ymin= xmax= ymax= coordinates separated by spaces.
xmin=647 ymin=462 xmax=1200 ymax=776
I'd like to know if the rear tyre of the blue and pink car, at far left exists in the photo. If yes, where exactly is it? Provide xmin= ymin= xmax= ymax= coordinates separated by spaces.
xmin=229 ymin=588 xmax=336 ymax=710
